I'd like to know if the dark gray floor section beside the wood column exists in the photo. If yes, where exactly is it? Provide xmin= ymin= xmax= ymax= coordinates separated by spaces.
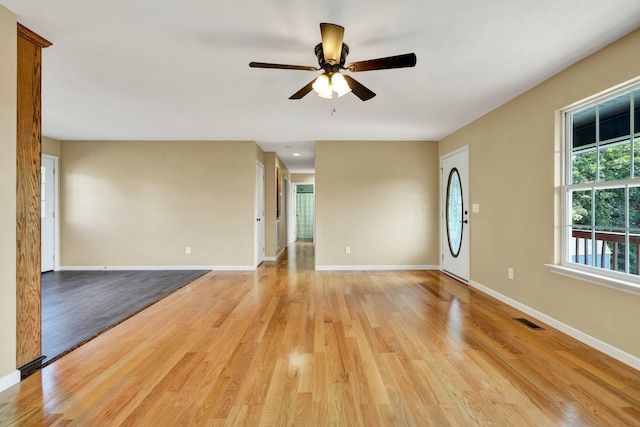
xmin=42 ymin=270 xmax=207 ymax=365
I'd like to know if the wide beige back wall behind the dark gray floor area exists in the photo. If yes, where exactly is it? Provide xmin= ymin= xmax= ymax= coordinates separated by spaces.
xmin=60 ymin=141 xmax=259 ymax=267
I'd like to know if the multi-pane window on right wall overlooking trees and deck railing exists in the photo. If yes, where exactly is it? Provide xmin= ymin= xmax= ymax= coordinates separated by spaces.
xmin=563 ymin=82 xmax=640 ymax=289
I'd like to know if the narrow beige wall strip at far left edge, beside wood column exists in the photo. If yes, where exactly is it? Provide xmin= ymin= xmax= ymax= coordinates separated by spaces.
xmin=0 ymin=6 xmax=18 ymax=380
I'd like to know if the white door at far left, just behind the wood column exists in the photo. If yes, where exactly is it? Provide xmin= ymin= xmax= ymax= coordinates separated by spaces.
xmin=40 ymin=156 xmax=56 ymax=272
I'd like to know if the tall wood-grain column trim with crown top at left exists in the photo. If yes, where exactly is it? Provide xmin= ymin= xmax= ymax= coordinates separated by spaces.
xmin=16 ymin=24 xmax=51 ymax=376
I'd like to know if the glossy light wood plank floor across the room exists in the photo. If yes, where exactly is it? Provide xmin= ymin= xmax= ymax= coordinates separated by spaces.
xmin=0 ymin=244 xmax=640 ymax=426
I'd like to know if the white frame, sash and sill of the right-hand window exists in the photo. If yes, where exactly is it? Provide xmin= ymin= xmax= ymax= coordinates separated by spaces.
xmin=549 ymin=78 xmax=640 ymax=295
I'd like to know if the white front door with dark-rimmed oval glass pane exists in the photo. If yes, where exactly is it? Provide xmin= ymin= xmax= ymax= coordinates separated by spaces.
xmin=440 ymin=147 xmax=470 ymax=282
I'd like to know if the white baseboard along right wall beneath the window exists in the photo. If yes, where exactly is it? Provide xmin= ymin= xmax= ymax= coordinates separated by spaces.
xmin=469 ymin=280 xmax=640 ymax=370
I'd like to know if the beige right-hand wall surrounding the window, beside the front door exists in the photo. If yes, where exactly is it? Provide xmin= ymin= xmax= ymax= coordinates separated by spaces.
xmin=440 ymin=30 xmax=640 ymax=357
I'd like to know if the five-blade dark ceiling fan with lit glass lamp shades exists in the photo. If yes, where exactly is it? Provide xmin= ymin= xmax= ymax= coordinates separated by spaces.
xmin=249 ymin=23 xmax=416 ymax=101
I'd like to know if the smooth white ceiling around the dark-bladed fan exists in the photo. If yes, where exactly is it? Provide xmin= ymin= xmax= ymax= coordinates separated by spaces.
xmin=0 ymin=0 xmax=640 ymax=172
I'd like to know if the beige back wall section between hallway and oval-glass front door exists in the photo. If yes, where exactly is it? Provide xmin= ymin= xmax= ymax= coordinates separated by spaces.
xmin=315 ymin=141 xmax=439 ymax=267
